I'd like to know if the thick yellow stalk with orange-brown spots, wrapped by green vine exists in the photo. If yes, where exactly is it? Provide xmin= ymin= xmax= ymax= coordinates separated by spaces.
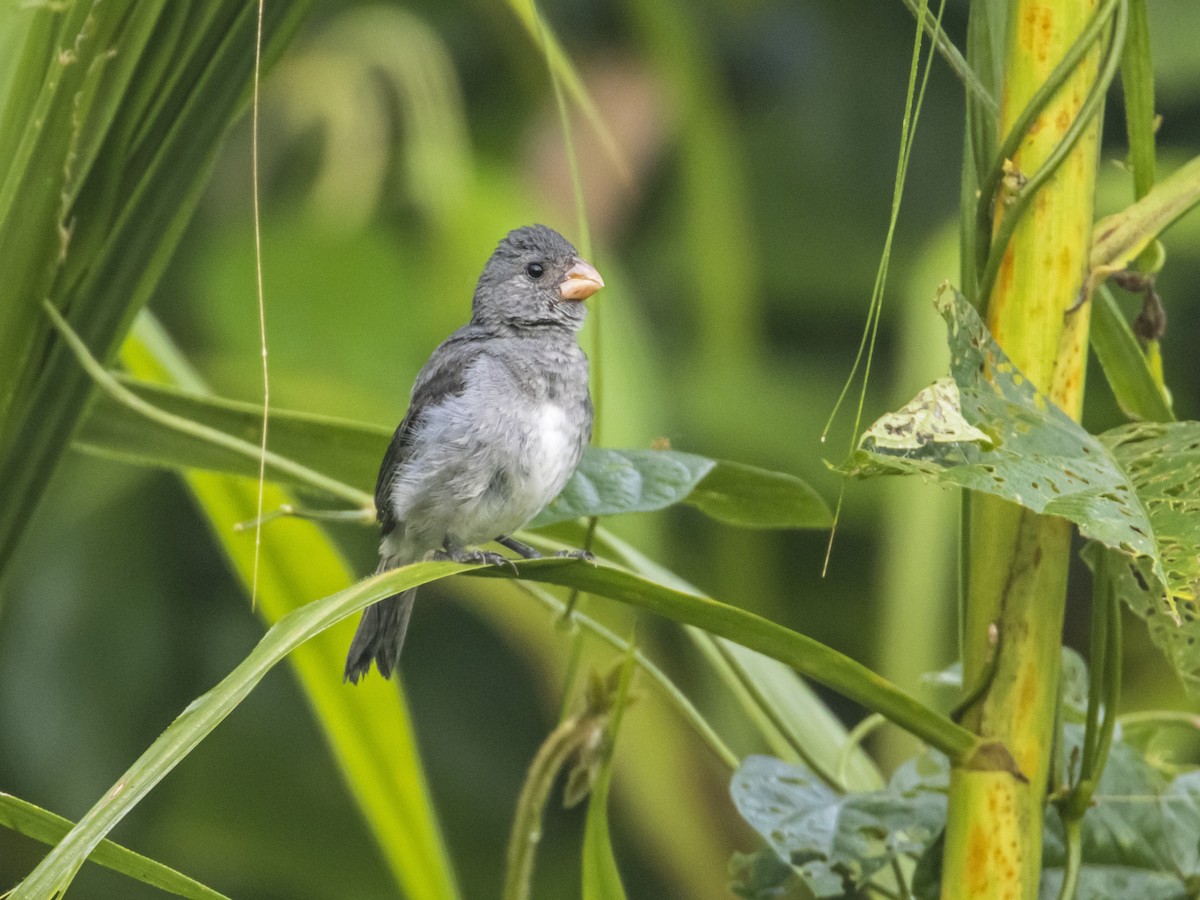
xmin=942 ymin=0 xmax=1100 ymax=900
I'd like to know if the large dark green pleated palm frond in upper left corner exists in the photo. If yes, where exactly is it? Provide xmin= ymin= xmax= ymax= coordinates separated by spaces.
xmin=0 ymin=1 xmax=308 ymax=571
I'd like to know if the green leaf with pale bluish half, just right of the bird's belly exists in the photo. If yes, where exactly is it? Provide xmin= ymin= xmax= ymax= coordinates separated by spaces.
xmin=529 ymin=448 xmax=830 ymax=528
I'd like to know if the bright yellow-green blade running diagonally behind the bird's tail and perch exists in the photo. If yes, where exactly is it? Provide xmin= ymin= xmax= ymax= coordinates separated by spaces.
xmin=122 ymin=316 xmax=457 ymax=900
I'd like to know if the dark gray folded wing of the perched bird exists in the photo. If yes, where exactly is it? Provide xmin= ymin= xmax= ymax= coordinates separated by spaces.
xmin=376 ymin=325 xmax=484 ymax=535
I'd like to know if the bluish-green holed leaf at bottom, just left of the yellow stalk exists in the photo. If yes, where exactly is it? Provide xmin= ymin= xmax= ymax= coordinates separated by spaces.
xmin=731 ymin=756 xmax=949 ymax=898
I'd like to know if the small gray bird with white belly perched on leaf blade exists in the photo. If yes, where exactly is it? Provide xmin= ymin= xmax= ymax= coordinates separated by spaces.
xmin=346 ymin=226 xmax=604 ymax=683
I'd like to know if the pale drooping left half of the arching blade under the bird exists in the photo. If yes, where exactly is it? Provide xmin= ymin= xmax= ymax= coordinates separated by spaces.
xmin=12 ymin=563 xmax=473 ymax=900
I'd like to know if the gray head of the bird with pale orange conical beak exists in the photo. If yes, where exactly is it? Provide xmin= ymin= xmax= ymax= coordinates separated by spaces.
xmin=472 ymin=224 xmax=604 ymax=331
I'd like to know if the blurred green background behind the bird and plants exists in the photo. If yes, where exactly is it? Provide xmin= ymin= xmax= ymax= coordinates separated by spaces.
xmin=0 ymin=0 xmax=1200 ymax=898
